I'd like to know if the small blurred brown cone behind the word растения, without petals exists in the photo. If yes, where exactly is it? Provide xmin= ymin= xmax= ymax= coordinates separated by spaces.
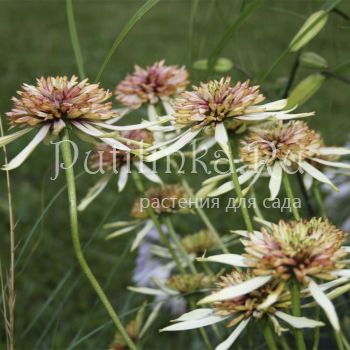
xmin=131 ymin=185 xmax=188 ymax=218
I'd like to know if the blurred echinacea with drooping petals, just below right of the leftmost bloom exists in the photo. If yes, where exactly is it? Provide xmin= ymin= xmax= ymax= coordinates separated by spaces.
xmin=78 ymin=129 xmax=162 ymax=210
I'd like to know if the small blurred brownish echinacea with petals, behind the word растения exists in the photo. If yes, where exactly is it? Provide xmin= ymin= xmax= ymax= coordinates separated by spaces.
xmin=104 ymin=185 xmax=188 ymax=251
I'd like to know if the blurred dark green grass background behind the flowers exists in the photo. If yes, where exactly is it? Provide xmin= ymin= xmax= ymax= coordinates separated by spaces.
xmin=0 ymin=0 xmax=350 ymax=349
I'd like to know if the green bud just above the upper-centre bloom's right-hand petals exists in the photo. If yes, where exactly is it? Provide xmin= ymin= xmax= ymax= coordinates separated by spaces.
xmin=286 ymin=73 xmax=325 ymax=109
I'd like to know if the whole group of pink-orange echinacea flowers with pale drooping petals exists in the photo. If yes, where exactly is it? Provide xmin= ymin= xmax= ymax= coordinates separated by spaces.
xmin=0 ymin=61 xmax=350 ymax=350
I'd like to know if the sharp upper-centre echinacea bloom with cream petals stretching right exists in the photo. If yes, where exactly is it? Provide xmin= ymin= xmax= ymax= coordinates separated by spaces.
xmin=146 ymin=77 xmax=313 ymax=161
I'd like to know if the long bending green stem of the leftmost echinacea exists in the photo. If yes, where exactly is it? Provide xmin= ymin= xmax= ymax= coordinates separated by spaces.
xmin=61 ymin=129 xmax=137 ymax=350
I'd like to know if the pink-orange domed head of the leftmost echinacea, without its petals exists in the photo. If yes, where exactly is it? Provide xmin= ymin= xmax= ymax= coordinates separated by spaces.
xmin=6 ymin=75 xmax=115 ymax=127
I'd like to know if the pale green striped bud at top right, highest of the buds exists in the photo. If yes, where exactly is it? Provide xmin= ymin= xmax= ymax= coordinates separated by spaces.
xmin=289 ymin=10 xmax=328 ymax=52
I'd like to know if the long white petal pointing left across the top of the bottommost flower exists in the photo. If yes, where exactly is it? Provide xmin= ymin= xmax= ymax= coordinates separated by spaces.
xmin=198 ymin=276 xmax=272 ymax=304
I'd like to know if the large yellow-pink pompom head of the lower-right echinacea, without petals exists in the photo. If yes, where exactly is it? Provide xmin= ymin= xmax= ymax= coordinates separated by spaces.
xmin=244 ymin=218 xmax=347 ymax=284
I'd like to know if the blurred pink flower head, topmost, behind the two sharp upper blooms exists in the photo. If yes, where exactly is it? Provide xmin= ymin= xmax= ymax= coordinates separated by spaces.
xmin=115 ymin=60 xmax=188 ymax=109
